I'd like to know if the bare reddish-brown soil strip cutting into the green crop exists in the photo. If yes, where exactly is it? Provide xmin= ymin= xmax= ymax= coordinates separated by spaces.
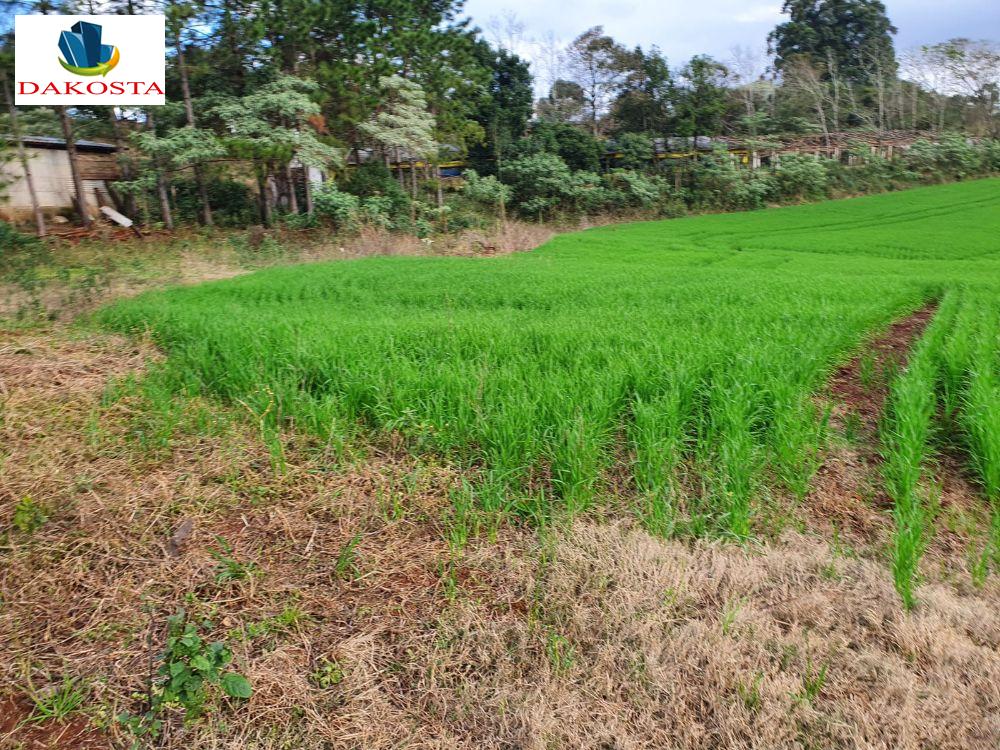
xmin=806 ymin=301 xmax=937 ymax=539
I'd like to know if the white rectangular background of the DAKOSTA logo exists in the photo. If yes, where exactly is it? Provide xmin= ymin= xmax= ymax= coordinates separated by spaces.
xmin=14 ymin=16 xmax=166 ymax=106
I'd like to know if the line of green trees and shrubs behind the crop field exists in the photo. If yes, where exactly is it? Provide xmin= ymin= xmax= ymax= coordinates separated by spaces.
xmin=0 ymin=0 xmax=1000 ymax=233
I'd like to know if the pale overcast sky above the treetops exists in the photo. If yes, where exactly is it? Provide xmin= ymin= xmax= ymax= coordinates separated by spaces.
xmin=465 ymin=0 xmax=1000 ymax=83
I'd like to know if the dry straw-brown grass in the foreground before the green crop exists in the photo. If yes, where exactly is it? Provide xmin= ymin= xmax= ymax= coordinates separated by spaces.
xmin=0 ymin=328 xmax=1000 ymax=750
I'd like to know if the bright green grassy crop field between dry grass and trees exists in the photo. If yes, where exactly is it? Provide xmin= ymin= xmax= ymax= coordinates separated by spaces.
xmin=99 ymin=180 xmax=1000 ymax=592
